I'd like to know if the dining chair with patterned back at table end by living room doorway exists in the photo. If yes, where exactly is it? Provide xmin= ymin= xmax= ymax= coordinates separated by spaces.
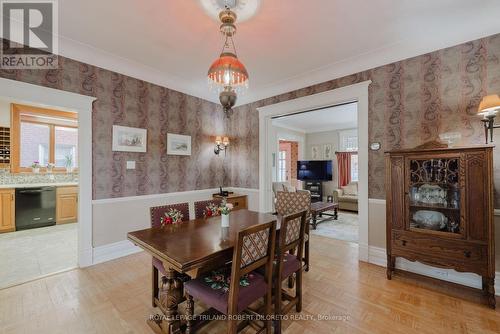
xmin=276 ymin=191 xmax=311 ymax=271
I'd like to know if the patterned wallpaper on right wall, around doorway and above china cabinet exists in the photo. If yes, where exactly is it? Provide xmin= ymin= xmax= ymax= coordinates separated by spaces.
xmin=227 ymin=34 xmax=500 ymax=207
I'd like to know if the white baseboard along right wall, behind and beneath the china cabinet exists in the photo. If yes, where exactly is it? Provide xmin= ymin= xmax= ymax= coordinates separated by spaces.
xmin=368 ymin=246 xmax=500 ymax=296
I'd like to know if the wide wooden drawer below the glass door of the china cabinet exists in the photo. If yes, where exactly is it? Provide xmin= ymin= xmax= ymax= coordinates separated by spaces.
xmin=392 ymin=231 xmax=487 ymax=264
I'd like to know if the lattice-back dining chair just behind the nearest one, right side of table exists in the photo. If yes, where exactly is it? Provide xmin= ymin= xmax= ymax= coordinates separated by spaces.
xmin=273 ymin=210 xmax=307 ymax=333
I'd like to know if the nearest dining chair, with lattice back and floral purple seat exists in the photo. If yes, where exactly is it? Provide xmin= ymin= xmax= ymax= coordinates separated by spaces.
xmin=184 ymin=221 xmax=276 ymax=334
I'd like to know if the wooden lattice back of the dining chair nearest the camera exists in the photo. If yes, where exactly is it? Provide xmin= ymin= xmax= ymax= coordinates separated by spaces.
xmin=228 ymin=221 xmax=276 ymax=314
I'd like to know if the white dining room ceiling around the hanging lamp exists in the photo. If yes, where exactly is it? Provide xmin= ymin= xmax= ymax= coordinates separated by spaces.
xmin=50 ymin=0 xmax=500 ymax=104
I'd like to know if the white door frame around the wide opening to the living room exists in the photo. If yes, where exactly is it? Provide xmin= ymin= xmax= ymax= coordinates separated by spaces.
xmin=257 ymin=80 xmax=371 ymax=261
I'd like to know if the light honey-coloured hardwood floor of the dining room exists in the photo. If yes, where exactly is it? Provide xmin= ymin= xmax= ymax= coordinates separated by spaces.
xmin=0 ymin=235 xmax=500 ymax=334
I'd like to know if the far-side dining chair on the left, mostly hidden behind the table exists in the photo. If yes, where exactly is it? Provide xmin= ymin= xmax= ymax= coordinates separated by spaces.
xmin=149 ymin=202 xmax=189 ymax=307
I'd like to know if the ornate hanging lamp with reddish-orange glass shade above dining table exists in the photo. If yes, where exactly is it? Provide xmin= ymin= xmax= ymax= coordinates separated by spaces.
xmin=208 ymin=6 xmax=248 ymax=114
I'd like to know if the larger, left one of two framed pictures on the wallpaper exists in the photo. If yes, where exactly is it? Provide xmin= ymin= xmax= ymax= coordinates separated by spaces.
xmin=112 ymin=125 xmax=148 ymax=153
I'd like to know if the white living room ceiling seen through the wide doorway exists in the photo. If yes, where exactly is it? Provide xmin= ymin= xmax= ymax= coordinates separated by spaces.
xmin=272 ymin=103 xmax=358 ymax=133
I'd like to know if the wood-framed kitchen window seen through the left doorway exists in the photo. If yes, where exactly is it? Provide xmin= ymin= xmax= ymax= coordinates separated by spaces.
xmin=11 ymin=104 xmax=78 ymax=173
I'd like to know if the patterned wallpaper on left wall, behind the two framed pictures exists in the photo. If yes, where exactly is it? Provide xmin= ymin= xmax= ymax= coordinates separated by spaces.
xmin=0 ymin=48 xmax=225 ymax=199
